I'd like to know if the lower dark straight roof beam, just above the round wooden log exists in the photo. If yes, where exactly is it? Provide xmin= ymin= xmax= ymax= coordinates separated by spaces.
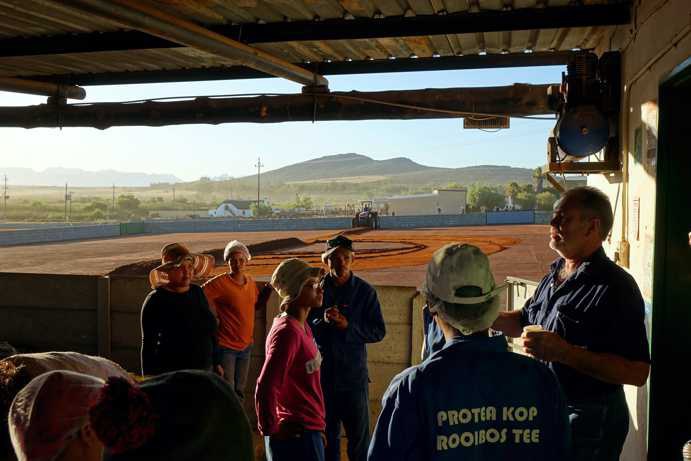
xmin=32 ymin=51 xmax=575 ymax=86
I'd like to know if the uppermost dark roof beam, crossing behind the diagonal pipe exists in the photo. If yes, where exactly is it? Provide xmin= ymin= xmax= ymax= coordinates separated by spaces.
xmin=0 ymin=3 xmax=631 ymax=57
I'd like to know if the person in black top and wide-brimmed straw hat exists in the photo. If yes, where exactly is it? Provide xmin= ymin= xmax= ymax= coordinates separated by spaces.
xmin=141 ymin=243 xmax=218 ymax=375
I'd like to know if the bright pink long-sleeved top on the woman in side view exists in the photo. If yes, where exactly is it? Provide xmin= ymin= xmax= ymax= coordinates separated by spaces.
xmin=254 ymin=314 xmax=326 ymax=435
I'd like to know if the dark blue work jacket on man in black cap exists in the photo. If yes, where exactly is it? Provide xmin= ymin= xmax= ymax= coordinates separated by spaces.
xmin=308 ymin=274 xmax=386 ymax=392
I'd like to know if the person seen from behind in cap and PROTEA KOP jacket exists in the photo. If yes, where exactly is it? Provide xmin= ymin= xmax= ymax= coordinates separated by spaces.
xmin=368 ymin=244 xmax=569 ymax=461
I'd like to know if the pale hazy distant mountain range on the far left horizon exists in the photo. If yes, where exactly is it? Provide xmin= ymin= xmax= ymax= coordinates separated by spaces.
xmin=0 ymin=166 xmax=181 ymax=187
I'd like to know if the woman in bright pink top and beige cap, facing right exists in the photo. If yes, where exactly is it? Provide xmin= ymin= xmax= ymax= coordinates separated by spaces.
xmin=254 ymin=258 xmax=326 ymax=461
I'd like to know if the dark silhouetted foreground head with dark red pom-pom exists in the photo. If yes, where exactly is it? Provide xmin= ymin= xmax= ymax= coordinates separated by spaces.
xmin=89 ymin=370 xmax=254 ymax=461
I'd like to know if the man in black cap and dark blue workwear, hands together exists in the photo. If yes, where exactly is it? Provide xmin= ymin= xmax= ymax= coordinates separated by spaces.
xmin=309 ymin=235 xmax=386 ymax=461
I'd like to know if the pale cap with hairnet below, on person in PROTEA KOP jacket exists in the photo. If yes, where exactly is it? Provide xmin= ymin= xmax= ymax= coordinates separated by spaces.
xmin=423 ymin=243 xmax=506 ymax=335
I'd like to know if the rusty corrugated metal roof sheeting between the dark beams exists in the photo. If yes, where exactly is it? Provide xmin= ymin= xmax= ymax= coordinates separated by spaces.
xmin=0 ymin=0 xmax=621 ymax=82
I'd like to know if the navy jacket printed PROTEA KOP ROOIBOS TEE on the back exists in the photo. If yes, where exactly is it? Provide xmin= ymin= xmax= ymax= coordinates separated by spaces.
xmin=367 ymin=335 xmax=570 ymax=461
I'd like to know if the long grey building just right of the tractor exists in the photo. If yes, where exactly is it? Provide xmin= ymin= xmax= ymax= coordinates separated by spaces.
xmin=377 ymin=189 xmax=468 ymax=216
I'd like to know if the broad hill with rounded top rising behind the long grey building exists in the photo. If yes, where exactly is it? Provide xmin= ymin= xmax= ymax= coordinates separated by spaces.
xmin=235 ymin=154 xmax=532 ymax=185
